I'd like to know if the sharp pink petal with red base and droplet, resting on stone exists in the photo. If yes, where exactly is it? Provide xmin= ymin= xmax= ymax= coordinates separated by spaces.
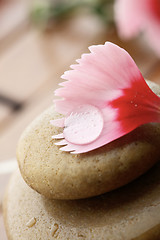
xmin=51 ymin=42 xmax=160 ymax=154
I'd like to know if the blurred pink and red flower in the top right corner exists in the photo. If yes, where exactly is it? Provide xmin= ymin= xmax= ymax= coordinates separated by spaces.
xmin=114 ymin=0 xmax=160 ymax=56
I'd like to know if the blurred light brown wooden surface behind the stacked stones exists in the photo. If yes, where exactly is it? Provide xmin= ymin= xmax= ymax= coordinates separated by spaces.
xmin=0 ymin=0 xmax=160 ymax=240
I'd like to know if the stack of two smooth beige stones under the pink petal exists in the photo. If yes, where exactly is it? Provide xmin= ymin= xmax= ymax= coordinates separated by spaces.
xmin=4 ymin=83 xmax=160 ymax=240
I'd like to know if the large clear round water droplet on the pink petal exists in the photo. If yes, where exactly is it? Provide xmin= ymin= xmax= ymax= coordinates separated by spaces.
xmin=63 ymin=104 xmax=104 ymax=145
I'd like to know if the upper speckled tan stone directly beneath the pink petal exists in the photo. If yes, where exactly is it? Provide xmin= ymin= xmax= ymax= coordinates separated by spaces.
xmin=17 ymin=80 xmax=160 ymax=199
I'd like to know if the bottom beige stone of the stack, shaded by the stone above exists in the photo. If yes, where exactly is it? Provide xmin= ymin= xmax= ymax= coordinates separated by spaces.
xmin=4 ymin=163 xmax=160 ymax=240
